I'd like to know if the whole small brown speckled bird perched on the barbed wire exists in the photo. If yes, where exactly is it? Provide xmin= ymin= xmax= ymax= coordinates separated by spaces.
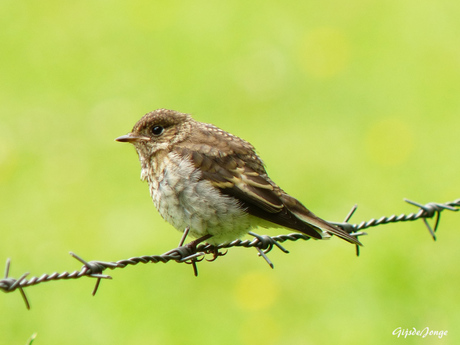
xmin=115 ymin=109 xmax=361 ymax=245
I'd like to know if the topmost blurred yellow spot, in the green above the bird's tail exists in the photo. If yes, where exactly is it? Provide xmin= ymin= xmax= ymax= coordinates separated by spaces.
xmin=300 ymin=27 xmax=350 ymax=79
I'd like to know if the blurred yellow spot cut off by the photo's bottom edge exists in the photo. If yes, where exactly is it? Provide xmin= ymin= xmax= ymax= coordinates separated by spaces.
xmin=239 ymin=313 xmax=280 ymax=345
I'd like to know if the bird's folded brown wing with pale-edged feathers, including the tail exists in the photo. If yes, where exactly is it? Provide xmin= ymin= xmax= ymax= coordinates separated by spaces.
xmin=178 ymin=127 xmax=361 ymax=245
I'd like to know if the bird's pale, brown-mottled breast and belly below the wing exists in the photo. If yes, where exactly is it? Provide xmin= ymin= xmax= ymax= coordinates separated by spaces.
xmin=145 ymin=153 xmax=250 ymax=243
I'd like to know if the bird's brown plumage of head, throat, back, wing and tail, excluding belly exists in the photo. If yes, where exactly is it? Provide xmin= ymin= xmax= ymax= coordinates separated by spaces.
xmin=117 ymin=109 xmax=360 ymax=245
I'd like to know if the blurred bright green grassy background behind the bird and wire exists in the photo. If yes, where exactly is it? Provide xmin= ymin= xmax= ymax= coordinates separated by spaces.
xmin=0 ymin=0 xmax=460 ymax=345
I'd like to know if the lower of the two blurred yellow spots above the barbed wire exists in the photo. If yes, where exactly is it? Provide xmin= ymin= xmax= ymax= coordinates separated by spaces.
xmin=366 ymin=118 xmax=414 ymax=166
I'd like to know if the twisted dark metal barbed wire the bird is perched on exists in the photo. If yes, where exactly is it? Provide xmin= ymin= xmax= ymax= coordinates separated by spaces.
xmin=0 ymin=199 xmax=460 ymax=309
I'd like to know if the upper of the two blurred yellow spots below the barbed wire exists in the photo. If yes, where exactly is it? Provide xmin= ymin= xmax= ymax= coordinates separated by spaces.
xmin=235 ymin=272 xmax=278 ymax=310
